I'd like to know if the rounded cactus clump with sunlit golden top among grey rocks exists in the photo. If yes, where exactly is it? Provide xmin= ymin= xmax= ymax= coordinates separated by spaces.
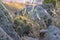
xmin=14 ymin=16 xmax=40 ymax=36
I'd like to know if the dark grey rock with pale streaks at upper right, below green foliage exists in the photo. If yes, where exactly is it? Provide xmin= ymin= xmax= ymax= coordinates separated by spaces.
xmin=42 ymin=3 xmax=56 ymax=16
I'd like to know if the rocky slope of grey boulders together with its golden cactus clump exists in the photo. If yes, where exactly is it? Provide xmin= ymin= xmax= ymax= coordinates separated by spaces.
xmin=0 ymin=1 xmax=60 ymax=40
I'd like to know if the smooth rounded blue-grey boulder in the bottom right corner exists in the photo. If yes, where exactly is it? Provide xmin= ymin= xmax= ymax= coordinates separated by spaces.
xmin=48 ymin=25 xmax=60 ymax=40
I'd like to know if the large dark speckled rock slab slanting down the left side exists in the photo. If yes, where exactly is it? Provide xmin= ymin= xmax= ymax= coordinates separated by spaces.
xmin=0 ymin=10 xmax=20 ymax=40
